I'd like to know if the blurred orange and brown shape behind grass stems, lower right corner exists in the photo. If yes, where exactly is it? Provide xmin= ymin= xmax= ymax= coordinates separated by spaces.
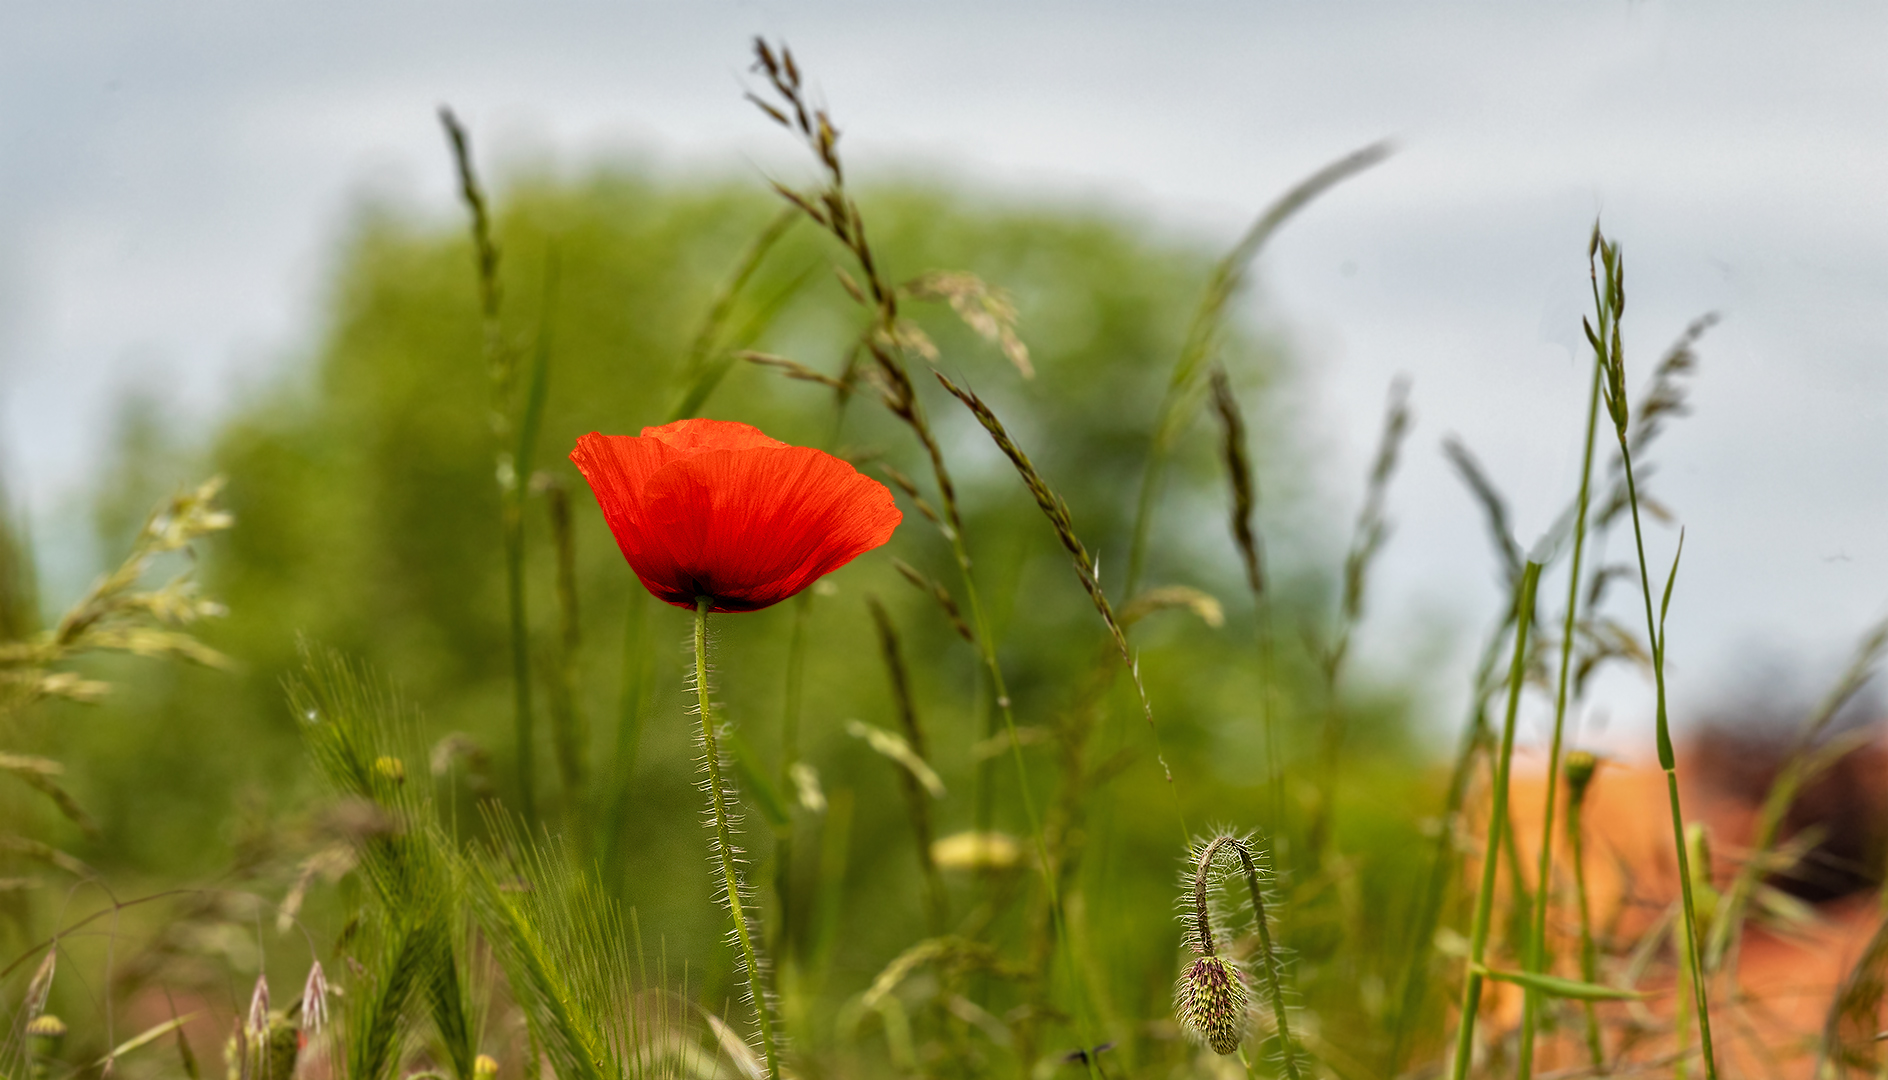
xmin=1476 ymin=729 xmax=1888 ymax=1078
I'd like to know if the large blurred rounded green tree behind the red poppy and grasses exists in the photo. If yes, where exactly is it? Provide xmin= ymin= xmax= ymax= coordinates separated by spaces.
xmin=7 ymin=170 xmax=1433 ymax=1054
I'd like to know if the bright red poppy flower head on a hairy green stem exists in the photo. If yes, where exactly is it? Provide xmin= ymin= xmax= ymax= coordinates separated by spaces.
xmin=570 ymin=419 xmax=904 ymax=612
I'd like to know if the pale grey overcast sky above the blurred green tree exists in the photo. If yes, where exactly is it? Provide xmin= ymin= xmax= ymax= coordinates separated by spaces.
xmin=0 ymin=0 xmax=1888 ymax=755
